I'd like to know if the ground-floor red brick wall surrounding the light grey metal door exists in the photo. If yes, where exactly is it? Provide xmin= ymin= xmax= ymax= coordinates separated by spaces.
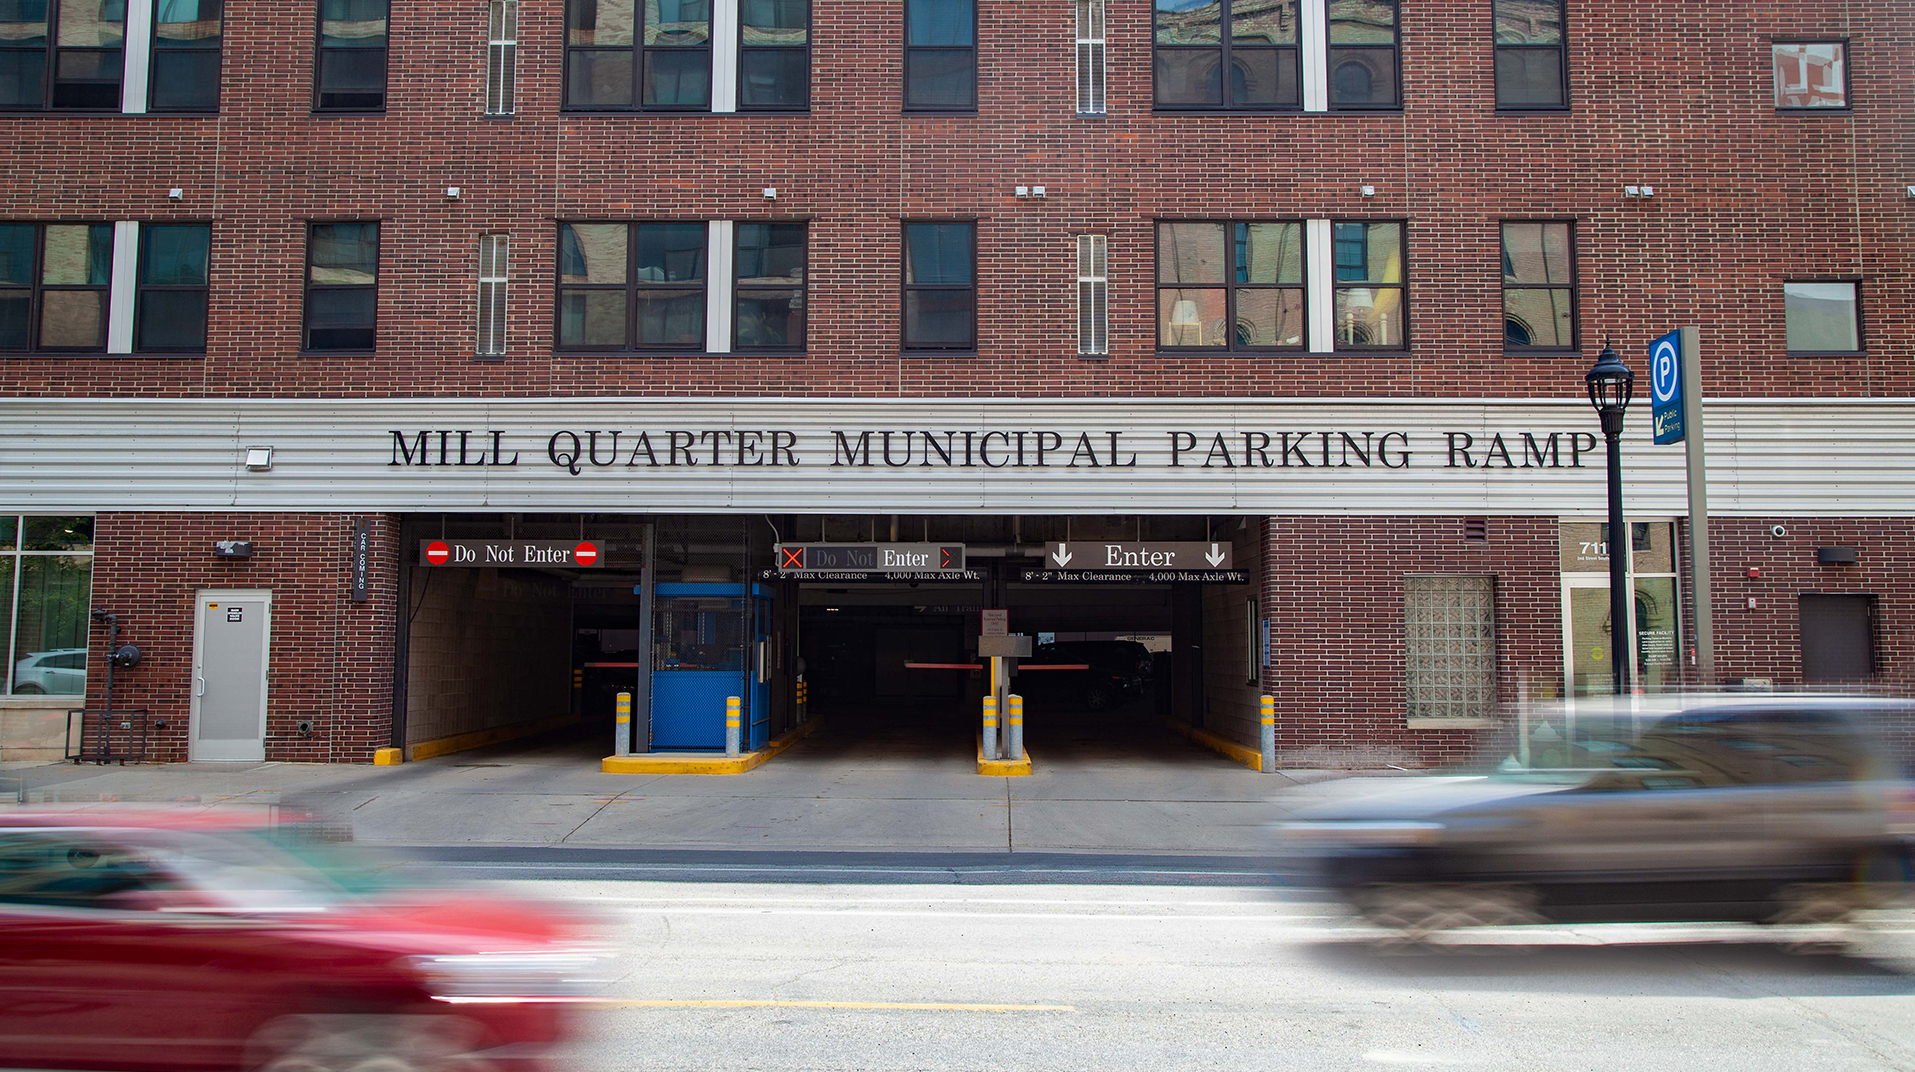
xmin=86 ymin=513 xmax=398 ymax=762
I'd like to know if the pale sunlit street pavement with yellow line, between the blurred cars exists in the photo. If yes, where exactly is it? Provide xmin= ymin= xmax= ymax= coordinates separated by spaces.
xmin=497 ymin=854 xmax=1915 ymax=1072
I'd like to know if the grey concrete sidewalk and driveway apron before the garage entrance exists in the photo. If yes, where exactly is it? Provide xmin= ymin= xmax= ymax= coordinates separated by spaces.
xmin=0 ymin=722 xmax=1388 ymax=856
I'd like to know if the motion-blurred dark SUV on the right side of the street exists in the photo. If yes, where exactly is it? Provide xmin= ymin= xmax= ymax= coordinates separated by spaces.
xmin=1279 ymin=695 xmax=1915 ymax=934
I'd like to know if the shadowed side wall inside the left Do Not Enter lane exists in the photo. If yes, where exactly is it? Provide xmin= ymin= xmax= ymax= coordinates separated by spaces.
xmin=406 ymin=569 xmax=573 ymax=745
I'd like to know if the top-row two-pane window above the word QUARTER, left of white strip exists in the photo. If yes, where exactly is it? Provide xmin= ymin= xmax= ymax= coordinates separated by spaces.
xmin=565 ymin=0 xmax=712 ymax=111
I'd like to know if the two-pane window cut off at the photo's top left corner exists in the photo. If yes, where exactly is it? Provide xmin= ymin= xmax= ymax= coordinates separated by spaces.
xmin=0 ymin=0 xmax=126 ymax=111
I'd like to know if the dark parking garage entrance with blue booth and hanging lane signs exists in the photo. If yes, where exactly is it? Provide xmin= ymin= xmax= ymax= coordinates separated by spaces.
xmin=400 ymin=515 xmax=1254 ymax=758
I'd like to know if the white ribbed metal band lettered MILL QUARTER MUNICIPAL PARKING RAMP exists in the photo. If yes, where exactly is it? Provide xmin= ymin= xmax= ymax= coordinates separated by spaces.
xmin=0 ymin=396 xmax=1915 ymax=517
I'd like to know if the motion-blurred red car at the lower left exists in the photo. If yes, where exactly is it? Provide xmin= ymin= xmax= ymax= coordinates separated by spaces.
xmin=0 ymin=812 xmax=597 ymax=1072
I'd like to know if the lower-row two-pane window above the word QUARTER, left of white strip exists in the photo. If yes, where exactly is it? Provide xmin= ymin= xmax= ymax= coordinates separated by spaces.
xmin=557 ymin=222 xmax=707 ymax=352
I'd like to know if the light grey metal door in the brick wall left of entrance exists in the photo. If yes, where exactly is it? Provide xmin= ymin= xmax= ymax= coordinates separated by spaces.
xmin=188 ymin=588 xmax=272 ymax=760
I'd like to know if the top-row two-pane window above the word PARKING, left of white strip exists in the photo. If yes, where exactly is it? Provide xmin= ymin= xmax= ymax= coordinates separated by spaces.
xmin=1155 ymin=0 xmax=1302 ymax=111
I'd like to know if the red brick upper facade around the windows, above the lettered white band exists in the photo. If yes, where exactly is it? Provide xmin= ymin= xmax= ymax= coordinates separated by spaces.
xmin=0 ymin=0 xmax=1915 ymax=396
